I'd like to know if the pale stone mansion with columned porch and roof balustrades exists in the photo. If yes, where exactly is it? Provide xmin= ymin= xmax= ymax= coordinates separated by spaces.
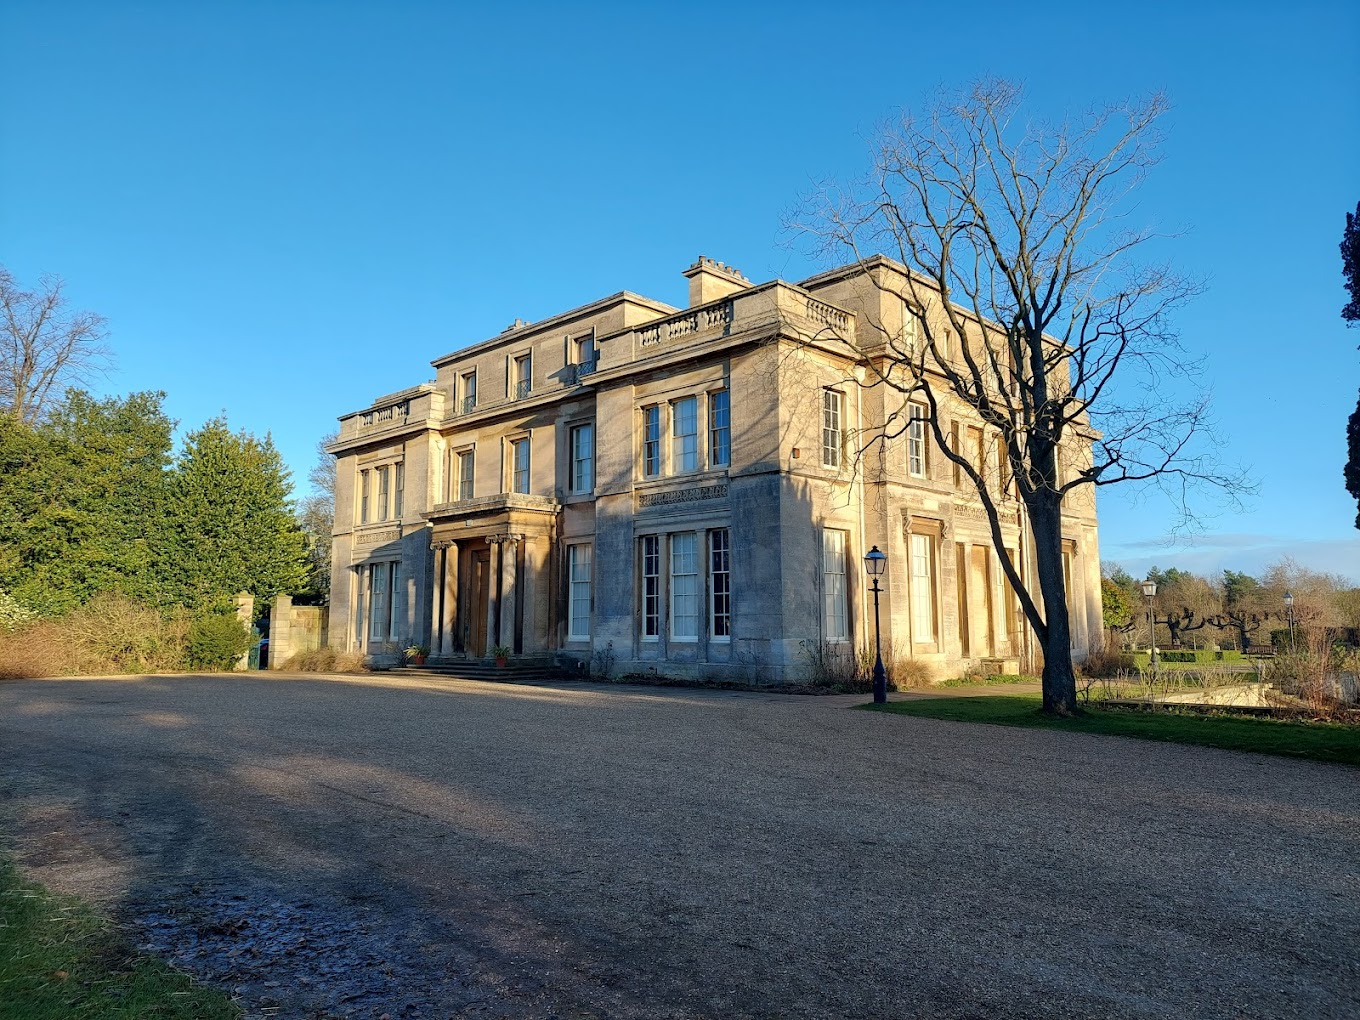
xmin=329 ymin=257 xmax=1100 ymax=681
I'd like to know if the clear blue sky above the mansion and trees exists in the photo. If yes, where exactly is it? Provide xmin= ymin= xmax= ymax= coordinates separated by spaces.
xmin=0 ymin=0 xmax=1360 ymax=581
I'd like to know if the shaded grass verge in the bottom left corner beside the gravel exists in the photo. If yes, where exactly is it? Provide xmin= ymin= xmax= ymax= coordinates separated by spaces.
xmin=0 ymin=858 xmax=241 ymax=1020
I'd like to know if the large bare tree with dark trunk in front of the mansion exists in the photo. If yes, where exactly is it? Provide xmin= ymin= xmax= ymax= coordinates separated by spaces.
xmin=793 ymin=80 xmax=1246 ymax=715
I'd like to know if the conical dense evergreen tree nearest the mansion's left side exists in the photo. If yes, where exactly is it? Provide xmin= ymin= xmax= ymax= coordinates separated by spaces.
xmin=165 ymin=418 xmax=307 ymax=608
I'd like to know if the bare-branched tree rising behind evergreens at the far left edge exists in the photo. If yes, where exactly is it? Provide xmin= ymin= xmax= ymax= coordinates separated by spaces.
xmin=0 ymin=265 xmax=110 ymax=422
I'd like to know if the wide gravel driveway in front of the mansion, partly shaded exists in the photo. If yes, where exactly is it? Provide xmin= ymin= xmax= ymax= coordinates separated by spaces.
xmin=0 ymin=676 xmax=1360 ymax=1020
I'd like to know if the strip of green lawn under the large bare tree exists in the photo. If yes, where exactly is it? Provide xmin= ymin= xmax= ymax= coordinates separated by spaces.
xmin=864 ymin=694 xmax=1360 ymax=767
